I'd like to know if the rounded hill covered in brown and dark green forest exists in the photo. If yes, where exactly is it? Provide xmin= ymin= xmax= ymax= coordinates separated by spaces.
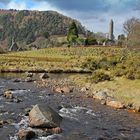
xmin=0 ymin=10 xmax=85 ymax=48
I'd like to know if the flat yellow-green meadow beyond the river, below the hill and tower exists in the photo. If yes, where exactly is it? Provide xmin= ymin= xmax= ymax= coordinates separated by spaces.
xmin=0 ymin=47 xmax=138 ymax=70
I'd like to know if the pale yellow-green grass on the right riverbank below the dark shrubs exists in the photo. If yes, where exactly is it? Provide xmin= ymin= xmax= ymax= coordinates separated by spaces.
xmin=70 ymin=75 xmax=140 ymax=108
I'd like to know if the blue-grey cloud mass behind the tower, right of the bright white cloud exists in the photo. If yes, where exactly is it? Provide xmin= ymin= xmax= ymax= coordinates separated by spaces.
xmin=29 ymin=0 xmax=140 ymax=35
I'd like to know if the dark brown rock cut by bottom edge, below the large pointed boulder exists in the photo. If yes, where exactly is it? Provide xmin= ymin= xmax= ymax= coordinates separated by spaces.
xmin=17 ymin=130 xmax=36 ymax=140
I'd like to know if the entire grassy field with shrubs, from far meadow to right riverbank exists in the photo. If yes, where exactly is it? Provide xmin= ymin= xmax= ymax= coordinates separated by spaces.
xmin=0 ymin=47 xmax=140 ymax=110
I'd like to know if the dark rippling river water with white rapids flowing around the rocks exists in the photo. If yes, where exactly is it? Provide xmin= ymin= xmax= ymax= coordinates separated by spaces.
xmin=0 ymin=75 xmax=140 ymax=140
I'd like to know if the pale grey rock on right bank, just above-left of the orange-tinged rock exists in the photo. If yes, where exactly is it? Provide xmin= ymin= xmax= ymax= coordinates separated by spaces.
xmin=93 ymin=91 xmax=108 ymax=100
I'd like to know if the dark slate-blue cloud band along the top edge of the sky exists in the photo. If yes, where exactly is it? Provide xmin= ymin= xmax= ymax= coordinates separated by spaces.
xmin=31 ymin=0 xmax=140 ymax=12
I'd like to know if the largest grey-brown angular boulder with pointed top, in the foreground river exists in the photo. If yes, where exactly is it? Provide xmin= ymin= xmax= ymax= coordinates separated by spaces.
xmin=29 ymin=104 xmax=62 ymax=128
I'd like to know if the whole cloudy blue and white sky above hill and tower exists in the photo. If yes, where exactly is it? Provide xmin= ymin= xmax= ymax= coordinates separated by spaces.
xmin=0 ymin=0 xmax=140 ymax=36
